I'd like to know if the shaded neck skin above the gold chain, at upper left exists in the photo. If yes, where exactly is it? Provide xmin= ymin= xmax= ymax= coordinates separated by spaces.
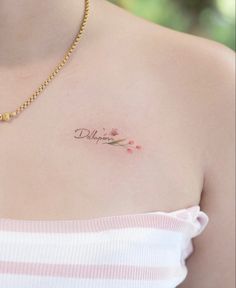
xmin=0 ymin=0 xmax=88 ymax=66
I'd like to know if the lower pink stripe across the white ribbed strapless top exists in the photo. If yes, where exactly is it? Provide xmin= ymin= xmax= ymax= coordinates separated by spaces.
xmin=0 ymin=262 xmax=182 ymax=280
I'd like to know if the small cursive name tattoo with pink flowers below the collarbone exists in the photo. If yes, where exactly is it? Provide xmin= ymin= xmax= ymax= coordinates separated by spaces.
xmin=74 ymin=128 xmax=142 ymax=154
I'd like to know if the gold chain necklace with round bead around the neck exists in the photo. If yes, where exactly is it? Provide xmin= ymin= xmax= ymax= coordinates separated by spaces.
xmin=0 ymin=0 xmax=90 ymax=122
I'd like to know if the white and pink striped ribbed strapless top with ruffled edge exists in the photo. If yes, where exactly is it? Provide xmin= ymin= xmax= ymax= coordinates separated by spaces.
xmin=0 ymin=206 xmax=209 ymax=288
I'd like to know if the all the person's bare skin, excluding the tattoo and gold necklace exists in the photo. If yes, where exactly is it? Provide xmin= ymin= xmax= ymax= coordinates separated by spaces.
xmin=0 ymin=0 xmax=235 ymax=288
